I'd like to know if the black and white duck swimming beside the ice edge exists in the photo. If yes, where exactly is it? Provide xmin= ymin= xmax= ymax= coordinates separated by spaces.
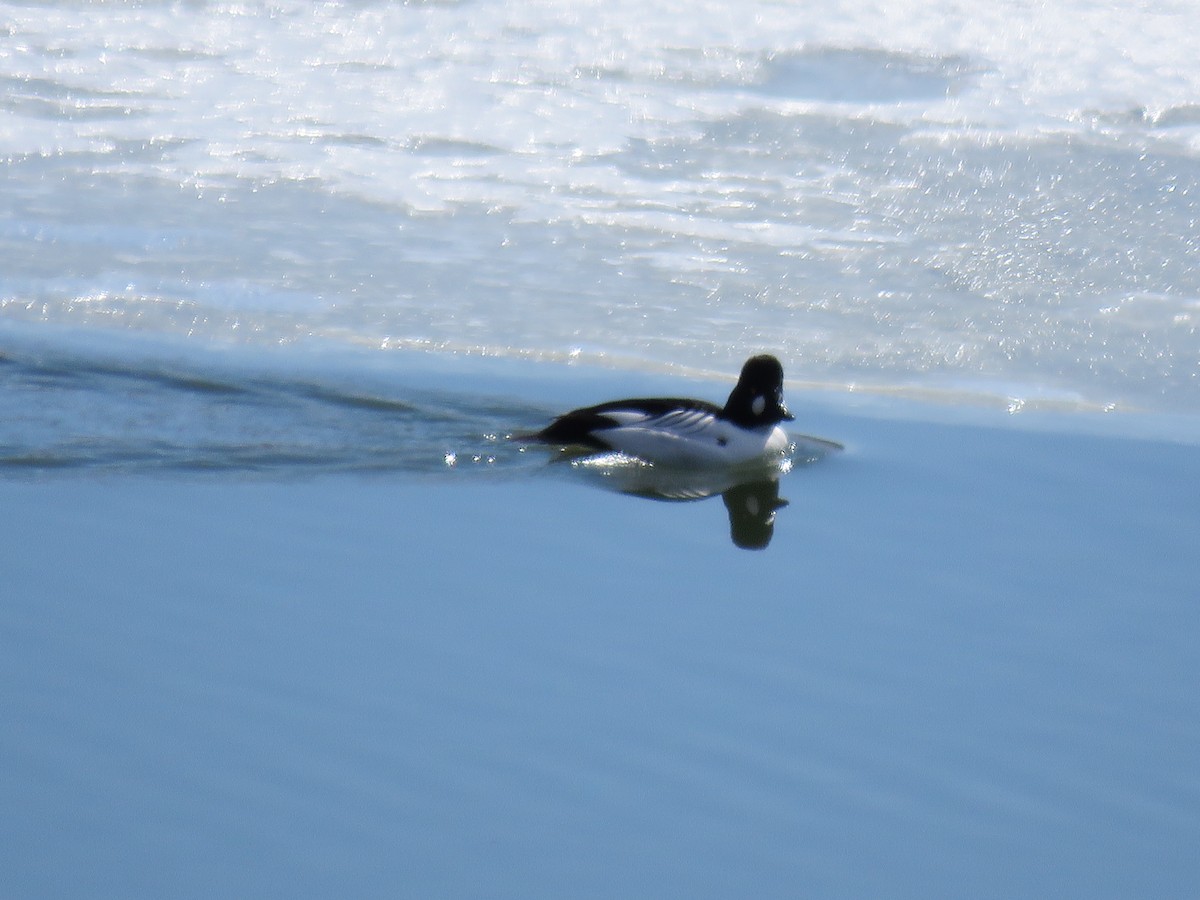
xmin=522 ymin=354 xmax=794 ymax=467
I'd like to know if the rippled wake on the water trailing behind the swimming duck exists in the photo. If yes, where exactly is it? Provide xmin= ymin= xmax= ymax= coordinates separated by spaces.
xmin=0 ymin=350 xmax=544 ymax=476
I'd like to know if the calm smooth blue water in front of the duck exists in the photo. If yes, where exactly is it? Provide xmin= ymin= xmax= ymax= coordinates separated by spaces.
xmin=0 ymin=413 xmax=1200 ymax=898
